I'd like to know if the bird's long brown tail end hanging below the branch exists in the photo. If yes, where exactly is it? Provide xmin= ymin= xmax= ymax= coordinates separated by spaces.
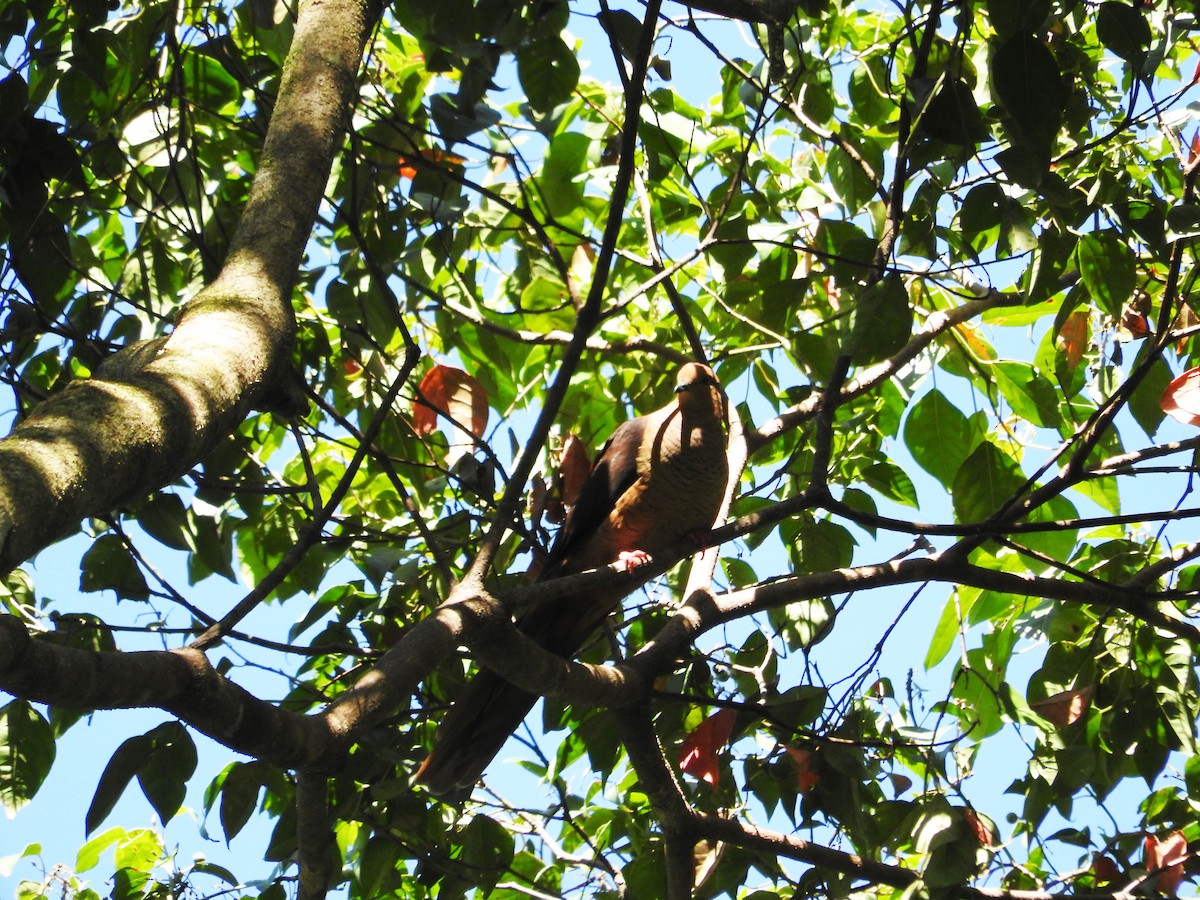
xmin=415 ymin=670 xmax=538 ymax=794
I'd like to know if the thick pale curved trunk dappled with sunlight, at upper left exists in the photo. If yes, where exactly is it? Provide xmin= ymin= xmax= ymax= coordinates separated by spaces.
xmin=0 ymin=0 xmax=377 ymax=571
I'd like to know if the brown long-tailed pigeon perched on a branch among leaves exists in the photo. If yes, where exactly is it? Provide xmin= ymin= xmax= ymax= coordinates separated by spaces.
xmin=414 ymin=362 xmax=728 ymax=796
